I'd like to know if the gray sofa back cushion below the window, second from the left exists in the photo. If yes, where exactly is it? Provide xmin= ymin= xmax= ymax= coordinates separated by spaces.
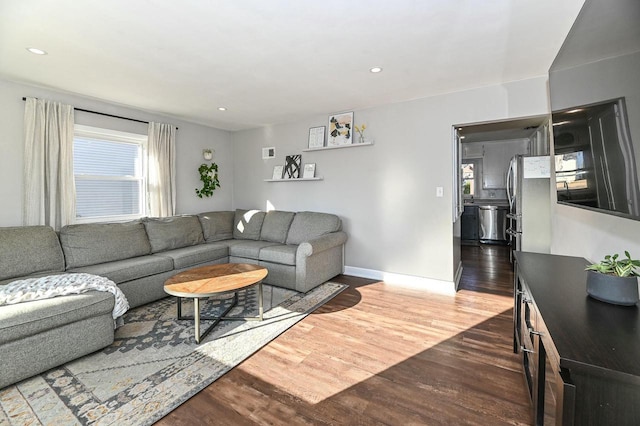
xmin=60 ymin=220 xmax=151 ymax=269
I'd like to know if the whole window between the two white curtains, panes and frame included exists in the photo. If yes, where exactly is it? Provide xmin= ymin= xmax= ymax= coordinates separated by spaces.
xmin=73 ymin=125 xmax=147 ymax=222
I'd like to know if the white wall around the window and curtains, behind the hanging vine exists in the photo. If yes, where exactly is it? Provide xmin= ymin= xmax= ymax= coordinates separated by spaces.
xmin=0 ymin=80 xmax=233 ymax=226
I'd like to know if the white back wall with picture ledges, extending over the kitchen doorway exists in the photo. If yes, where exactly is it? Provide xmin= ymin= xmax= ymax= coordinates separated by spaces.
xmin=233 ymin=77 xmax=548 ymax=283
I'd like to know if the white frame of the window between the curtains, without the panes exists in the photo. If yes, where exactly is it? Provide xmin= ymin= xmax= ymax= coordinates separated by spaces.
xmin=73 ymin=124 xmax=148 ymax=223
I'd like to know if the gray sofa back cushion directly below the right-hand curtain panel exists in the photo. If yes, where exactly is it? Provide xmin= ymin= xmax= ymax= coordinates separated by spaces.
xmin=143 ymin=216 xmax=204 ymax=253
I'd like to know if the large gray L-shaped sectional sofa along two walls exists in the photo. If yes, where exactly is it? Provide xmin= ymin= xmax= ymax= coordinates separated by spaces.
xmin=0 ymin=210 xmax=347 ymax=388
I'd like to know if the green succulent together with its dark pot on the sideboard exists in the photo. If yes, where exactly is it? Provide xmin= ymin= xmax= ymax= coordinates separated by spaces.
xmin=586 ymin=251 xmax=640 ymax=306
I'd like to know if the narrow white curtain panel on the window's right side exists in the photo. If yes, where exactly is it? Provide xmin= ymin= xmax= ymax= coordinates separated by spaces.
xmin=147 ymin=122 xmax=176 ymax=217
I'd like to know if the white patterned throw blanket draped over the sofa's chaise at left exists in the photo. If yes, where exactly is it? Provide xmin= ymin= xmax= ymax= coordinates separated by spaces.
xmin=0 ymin=274 xmax=129 ymax=319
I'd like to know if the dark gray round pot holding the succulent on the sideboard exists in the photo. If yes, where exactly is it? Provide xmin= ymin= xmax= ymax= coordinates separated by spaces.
xmin=587 ymin=271 xmax=639 ymax=306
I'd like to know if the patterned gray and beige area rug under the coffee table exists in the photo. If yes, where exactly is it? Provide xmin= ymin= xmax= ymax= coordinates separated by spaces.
xmin=0 ymin=282 xmax=347 ymax=426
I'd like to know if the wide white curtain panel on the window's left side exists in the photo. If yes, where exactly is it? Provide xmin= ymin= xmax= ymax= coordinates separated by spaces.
xmin=23 ymin=98 xmax=76 ymax=230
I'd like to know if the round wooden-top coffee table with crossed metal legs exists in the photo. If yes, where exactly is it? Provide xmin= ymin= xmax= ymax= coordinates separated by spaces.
xmin=164 ymin=263 xmax=268 ymax=343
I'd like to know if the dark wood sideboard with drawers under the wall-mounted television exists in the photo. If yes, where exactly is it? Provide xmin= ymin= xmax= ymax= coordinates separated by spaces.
xmin=513 ymin=252 xmax=640 ymax=426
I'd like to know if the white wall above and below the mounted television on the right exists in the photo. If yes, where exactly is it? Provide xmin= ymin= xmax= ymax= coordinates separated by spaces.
xmin=550 ymin=52 xmax=640 ymax=261
